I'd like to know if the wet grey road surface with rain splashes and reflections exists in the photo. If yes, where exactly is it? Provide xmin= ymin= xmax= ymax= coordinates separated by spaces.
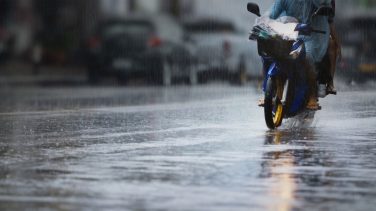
xmin=0 ymin=85 xmax=376 ymax=211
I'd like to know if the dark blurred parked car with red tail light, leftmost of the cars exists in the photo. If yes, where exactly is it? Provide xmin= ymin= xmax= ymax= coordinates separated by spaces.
xmin=87 ymin=15 xmax=197 ymax=85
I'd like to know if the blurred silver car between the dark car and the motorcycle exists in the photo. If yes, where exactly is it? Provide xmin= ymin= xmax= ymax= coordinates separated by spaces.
xmin=183 ymin=18 xmax=262 ymax=84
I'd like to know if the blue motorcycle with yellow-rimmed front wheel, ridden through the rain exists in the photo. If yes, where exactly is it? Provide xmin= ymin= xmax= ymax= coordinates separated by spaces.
xmin=247 ymin=3 xmax=333 ymax=129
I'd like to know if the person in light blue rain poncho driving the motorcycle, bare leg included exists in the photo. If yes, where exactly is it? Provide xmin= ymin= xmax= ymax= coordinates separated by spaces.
xmin=269 ymin=0 xmax=330 ymax=110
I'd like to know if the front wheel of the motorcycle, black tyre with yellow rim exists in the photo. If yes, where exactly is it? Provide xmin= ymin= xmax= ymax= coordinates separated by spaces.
xmin=264 ymin=77 xmax=285 ymax=129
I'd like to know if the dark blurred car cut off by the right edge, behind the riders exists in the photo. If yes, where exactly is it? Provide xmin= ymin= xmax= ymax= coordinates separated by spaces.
xmin=337 ymin=14 xmax=376 ymax=81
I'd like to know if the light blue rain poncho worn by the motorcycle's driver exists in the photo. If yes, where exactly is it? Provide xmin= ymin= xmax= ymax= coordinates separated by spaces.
xmin=269 ymin=0 xmax=330 ymax=63
